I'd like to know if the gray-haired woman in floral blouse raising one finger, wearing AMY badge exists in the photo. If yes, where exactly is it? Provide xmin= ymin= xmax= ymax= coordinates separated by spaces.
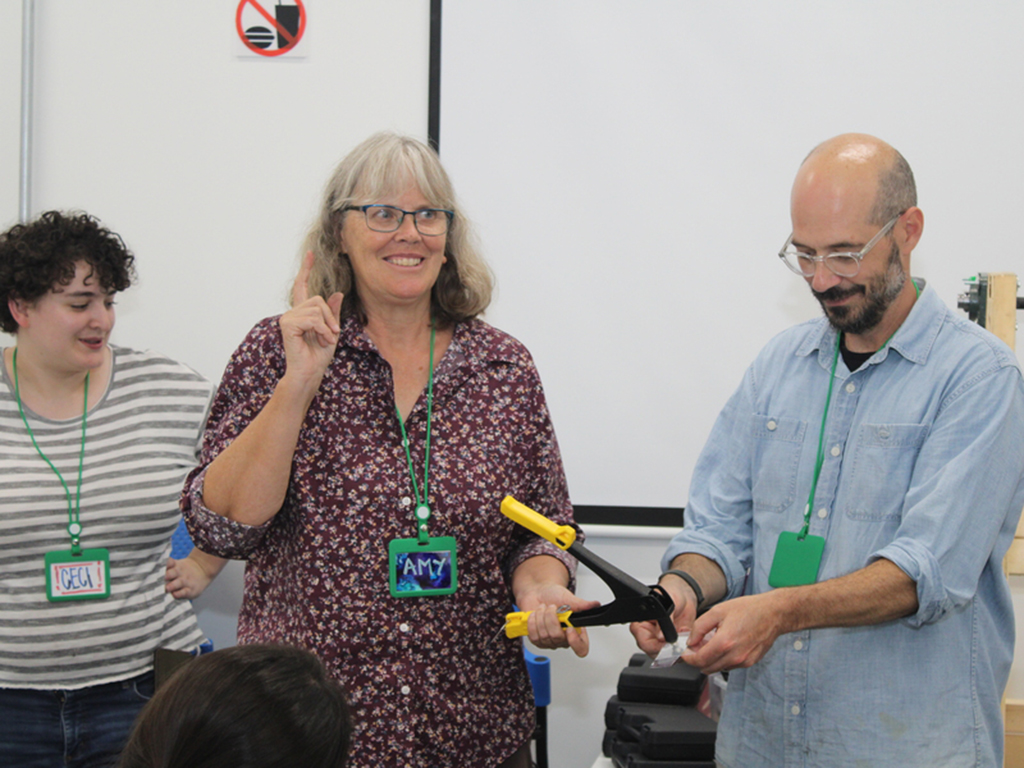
xmin=183 ymin=133 xmax=594 ymax=767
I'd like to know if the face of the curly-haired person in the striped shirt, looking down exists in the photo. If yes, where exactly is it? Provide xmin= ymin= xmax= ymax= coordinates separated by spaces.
xmin=10 ymin=261 xmax=114 ymax=373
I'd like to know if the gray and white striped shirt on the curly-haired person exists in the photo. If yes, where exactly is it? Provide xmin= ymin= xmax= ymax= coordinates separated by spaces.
xmin=0 ymin=346 xmax=212 ymax=689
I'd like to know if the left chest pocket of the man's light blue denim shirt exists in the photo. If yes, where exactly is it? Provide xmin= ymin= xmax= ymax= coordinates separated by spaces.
xmin=751 ymin=415 xmax=807 ymax=512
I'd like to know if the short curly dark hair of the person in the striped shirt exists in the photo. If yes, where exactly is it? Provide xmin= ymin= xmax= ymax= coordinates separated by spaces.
xmin=0 ymin=211 xmax=135 ymax=334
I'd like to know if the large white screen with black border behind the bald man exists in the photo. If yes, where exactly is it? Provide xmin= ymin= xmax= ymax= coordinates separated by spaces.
xmin=440 ymin=0 xmax=1024 ymax=507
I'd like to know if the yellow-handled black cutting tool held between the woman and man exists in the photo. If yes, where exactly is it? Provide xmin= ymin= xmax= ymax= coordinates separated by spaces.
xmin=502 ymin=496 xmax=679 ymax=643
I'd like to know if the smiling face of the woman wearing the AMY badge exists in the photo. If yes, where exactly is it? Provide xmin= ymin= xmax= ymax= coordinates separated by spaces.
xmin=339 ymin=183 xmax=446 ymax=316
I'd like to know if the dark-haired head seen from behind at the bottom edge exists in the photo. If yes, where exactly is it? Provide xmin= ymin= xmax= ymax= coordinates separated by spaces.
xmin=118 ymin=645 xmax=351 ymax=768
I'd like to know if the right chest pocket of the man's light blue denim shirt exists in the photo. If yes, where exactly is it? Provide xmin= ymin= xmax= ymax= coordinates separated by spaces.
xmin=844 ymin=424 xmax=928 ymax=521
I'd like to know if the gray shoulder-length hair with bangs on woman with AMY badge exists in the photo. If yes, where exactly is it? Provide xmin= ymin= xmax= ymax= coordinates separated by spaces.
xmin=302 ymin=132 xmax=494 ymax=327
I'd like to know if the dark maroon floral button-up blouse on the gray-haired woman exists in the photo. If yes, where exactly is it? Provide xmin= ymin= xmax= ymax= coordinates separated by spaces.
xmin=181 ymin=317 xmax=575 ymax=768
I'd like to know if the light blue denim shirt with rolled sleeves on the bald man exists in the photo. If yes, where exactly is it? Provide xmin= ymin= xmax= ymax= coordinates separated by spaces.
xmin=663 ymin=289 xmax=1024 ymax=768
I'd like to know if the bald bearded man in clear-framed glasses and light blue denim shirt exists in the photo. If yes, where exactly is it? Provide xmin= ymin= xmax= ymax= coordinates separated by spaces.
xmin=632 ymin=134 xmax=1024 ymax=768
